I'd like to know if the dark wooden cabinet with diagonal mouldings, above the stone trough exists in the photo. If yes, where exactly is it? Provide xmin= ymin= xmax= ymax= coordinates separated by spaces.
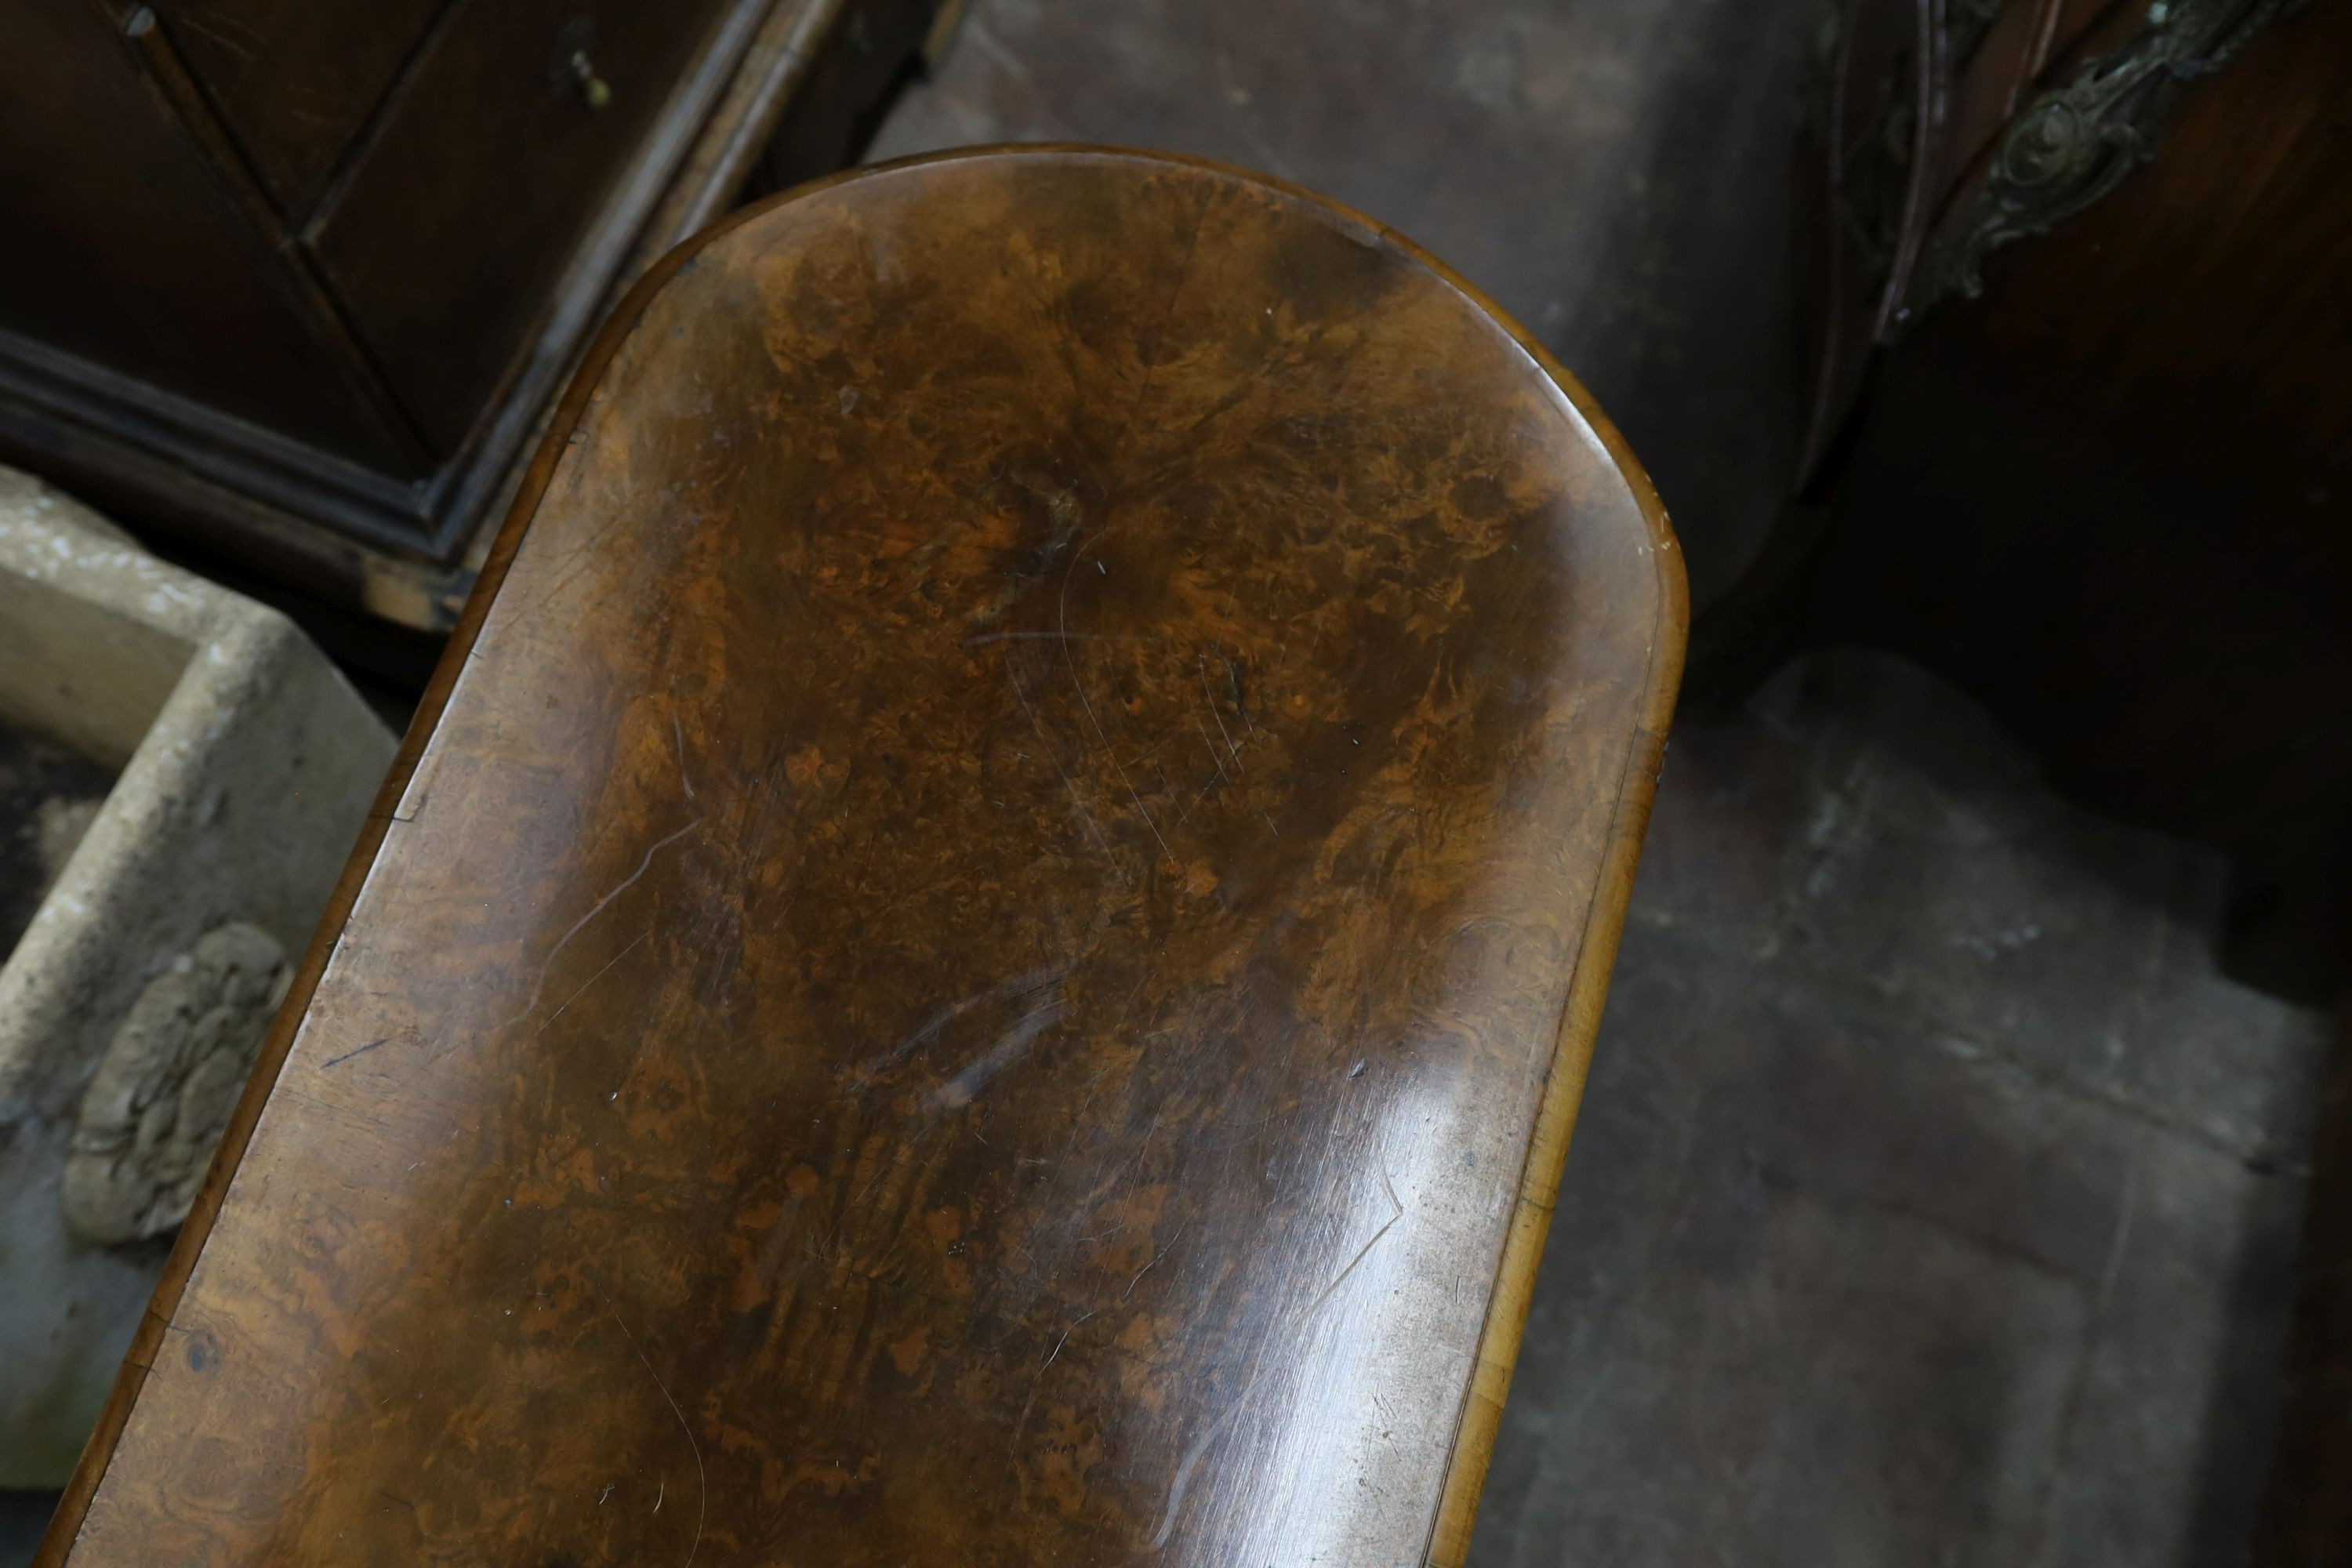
xmin=0 ymin=0 xmax=936 ymax=630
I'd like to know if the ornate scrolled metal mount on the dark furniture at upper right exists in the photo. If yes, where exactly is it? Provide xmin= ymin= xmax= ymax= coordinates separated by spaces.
xmin=1910 ymin=0 xmax=2310 ymax=320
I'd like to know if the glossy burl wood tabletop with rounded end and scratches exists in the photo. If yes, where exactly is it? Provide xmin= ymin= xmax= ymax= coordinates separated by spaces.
xmin=42 ymin=148 xmax=1684 ymax=1568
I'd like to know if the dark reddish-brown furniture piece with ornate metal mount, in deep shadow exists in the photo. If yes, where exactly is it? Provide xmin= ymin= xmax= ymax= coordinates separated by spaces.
xmin=1693 ymin=0 xmax=2352 ymax=1001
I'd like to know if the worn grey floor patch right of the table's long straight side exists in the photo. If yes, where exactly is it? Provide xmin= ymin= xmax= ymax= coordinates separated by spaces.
xmin=1472 ymin=654 xmax=2328 ymax=1568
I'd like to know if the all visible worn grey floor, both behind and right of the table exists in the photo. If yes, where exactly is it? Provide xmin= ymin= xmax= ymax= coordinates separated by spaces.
xmin=873 ymin=0 xmax=2328 ymax=1568
